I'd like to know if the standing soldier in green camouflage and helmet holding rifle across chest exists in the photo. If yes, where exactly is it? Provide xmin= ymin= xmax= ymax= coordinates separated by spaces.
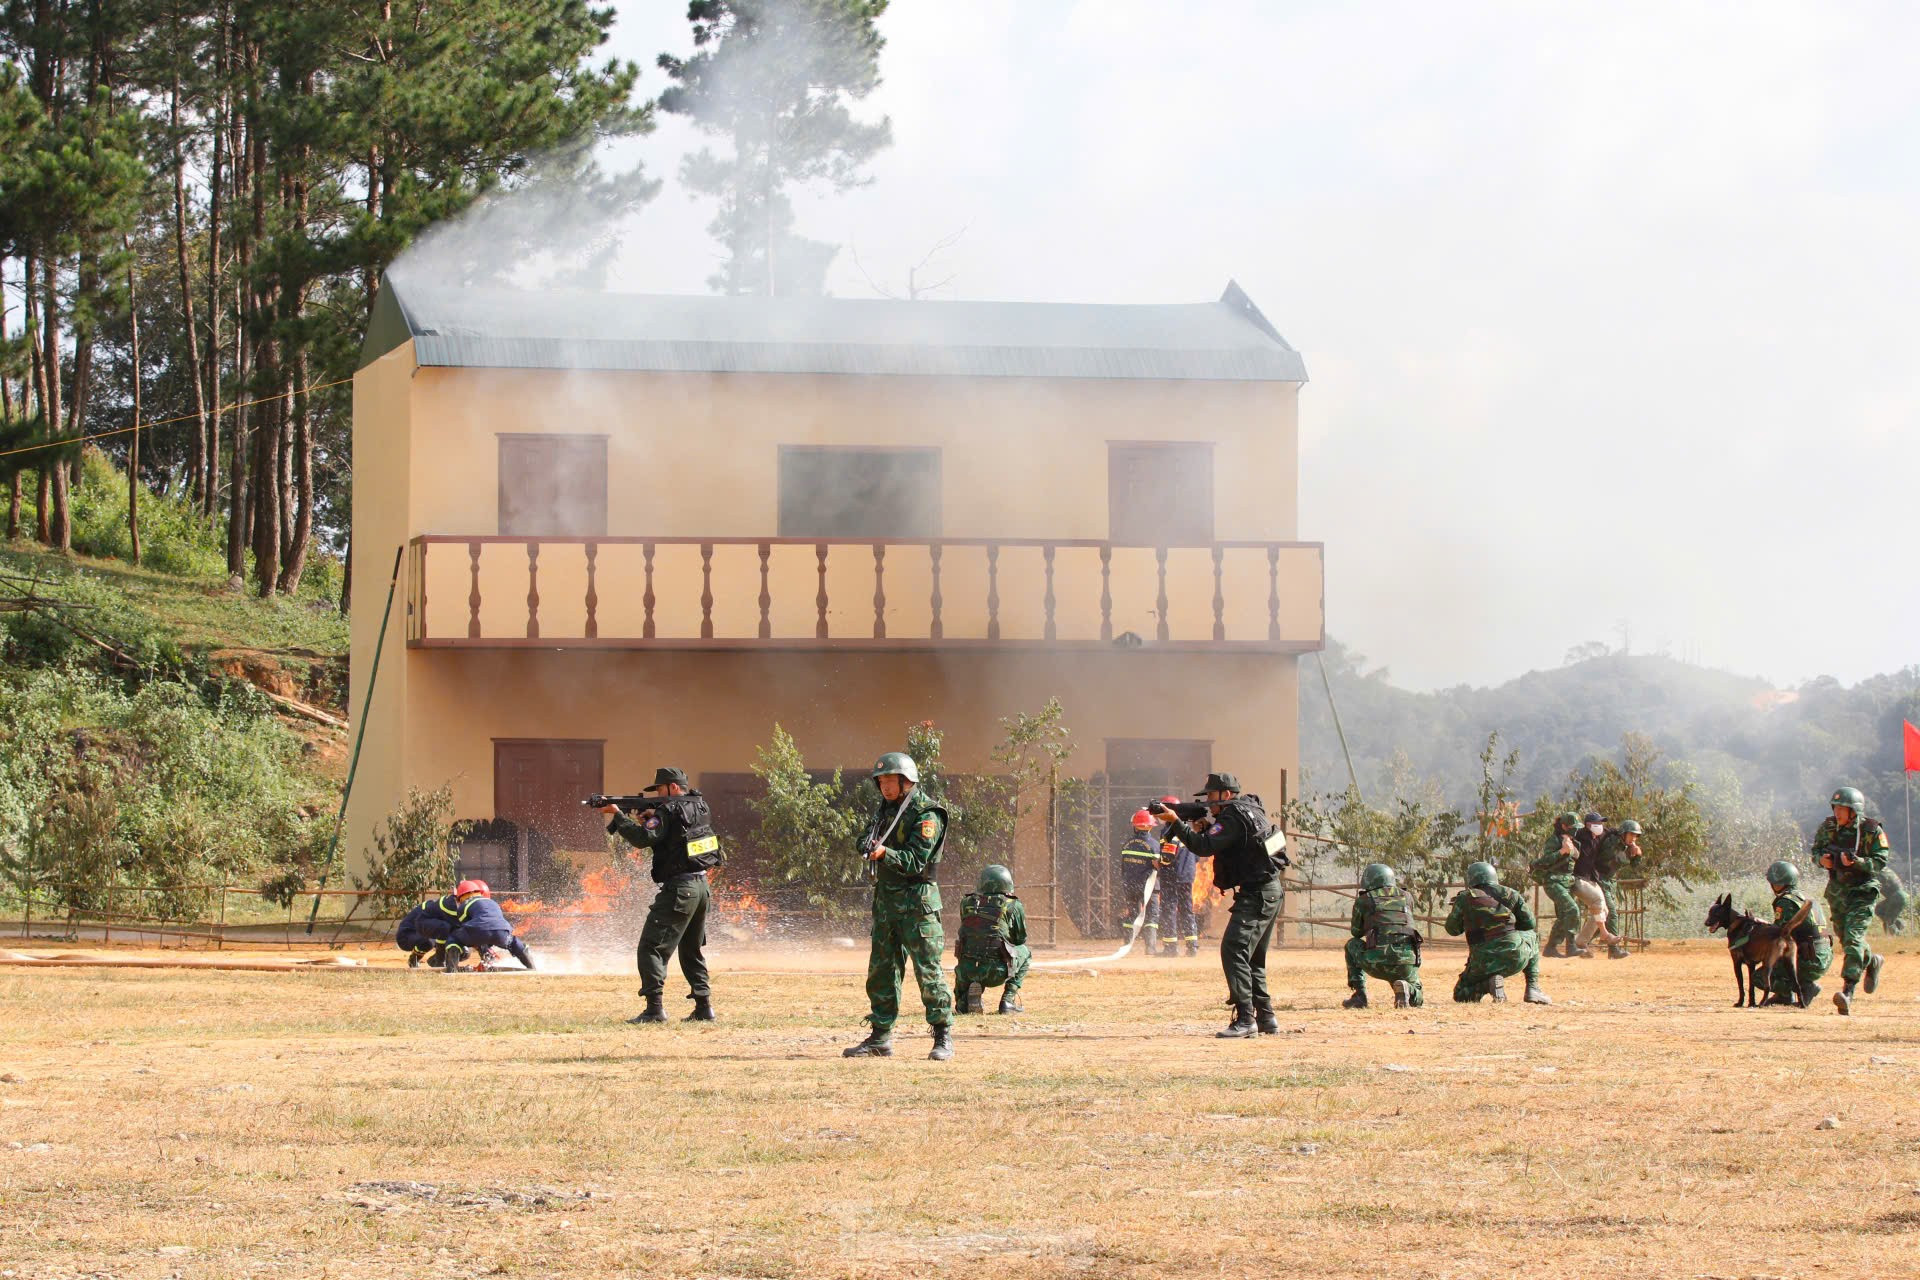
xmin=845 ymin=750 xmax=954 ymax=1061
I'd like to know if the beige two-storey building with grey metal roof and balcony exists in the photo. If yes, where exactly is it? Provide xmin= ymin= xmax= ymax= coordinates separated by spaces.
xmin=346 ymin=278 xmax=1325 ymax=936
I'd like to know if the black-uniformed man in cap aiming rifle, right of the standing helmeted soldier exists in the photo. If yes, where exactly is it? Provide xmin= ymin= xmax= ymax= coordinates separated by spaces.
xmin=1146 ymin=773 xmax=1292 ymax=1040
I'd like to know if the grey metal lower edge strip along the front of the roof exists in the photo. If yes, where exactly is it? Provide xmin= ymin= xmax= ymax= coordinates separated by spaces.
xmin=415 ymin=332 xmax=1308 ymax=382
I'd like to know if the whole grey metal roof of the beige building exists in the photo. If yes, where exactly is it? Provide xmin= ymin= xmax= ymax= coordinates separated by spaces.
xmin=361 ymin=276 xmax=1306 ymax=382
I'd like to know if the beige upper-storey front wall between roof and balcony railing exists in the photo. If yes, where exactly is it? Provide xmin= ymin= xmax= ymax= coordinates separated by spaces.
xmin=413 ymin=368 xmax=1298 ymax=541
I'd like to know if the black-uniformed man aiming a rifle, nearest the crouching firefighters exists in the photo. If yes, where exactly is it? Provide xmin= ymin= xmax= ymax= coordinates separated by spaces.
xmin=601 ymin=768 xmax=722 ymax=1023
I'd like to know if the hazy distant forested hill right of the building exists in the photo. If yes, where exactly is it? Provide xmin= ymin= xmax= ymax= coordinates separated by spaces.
xmin=1300 ymin=641 xmax=1920 ymax=846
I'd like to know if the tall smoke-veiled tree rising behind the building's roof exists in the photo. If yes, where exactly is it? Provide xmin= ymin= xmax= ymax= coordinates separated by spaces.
xmin=659 ymin=0 xmax=893 ymax=297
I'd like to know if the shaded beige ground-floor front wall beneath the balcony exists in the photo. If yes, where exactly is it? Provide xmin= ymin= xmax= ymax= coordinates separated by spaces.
xmin=403 ymin=649 xmax=1300 ymax=882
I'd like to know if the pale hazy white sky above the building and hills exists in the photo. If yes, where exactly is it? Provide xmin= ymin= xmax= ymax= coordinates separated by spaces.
xmin=591 ymin=0 xmax=1920 ymax=687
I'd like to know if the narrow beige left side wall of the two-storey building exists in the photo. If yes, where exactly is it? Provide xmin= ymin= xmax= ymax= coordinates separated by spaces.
xmin=340 ymin=342 xmax=413 ymax=867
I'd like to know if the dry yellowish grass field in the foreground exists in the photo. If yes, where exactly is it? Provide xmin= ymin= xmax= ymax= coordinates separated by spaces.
xmin=0 ymin=938 xmax=1920 ymax=1280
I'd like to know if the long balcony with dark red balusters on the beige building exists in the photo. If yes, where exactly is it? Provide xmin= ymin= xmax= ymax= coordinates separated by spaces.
xmin=407 ymin=533 xmax=1325 ymax=652
